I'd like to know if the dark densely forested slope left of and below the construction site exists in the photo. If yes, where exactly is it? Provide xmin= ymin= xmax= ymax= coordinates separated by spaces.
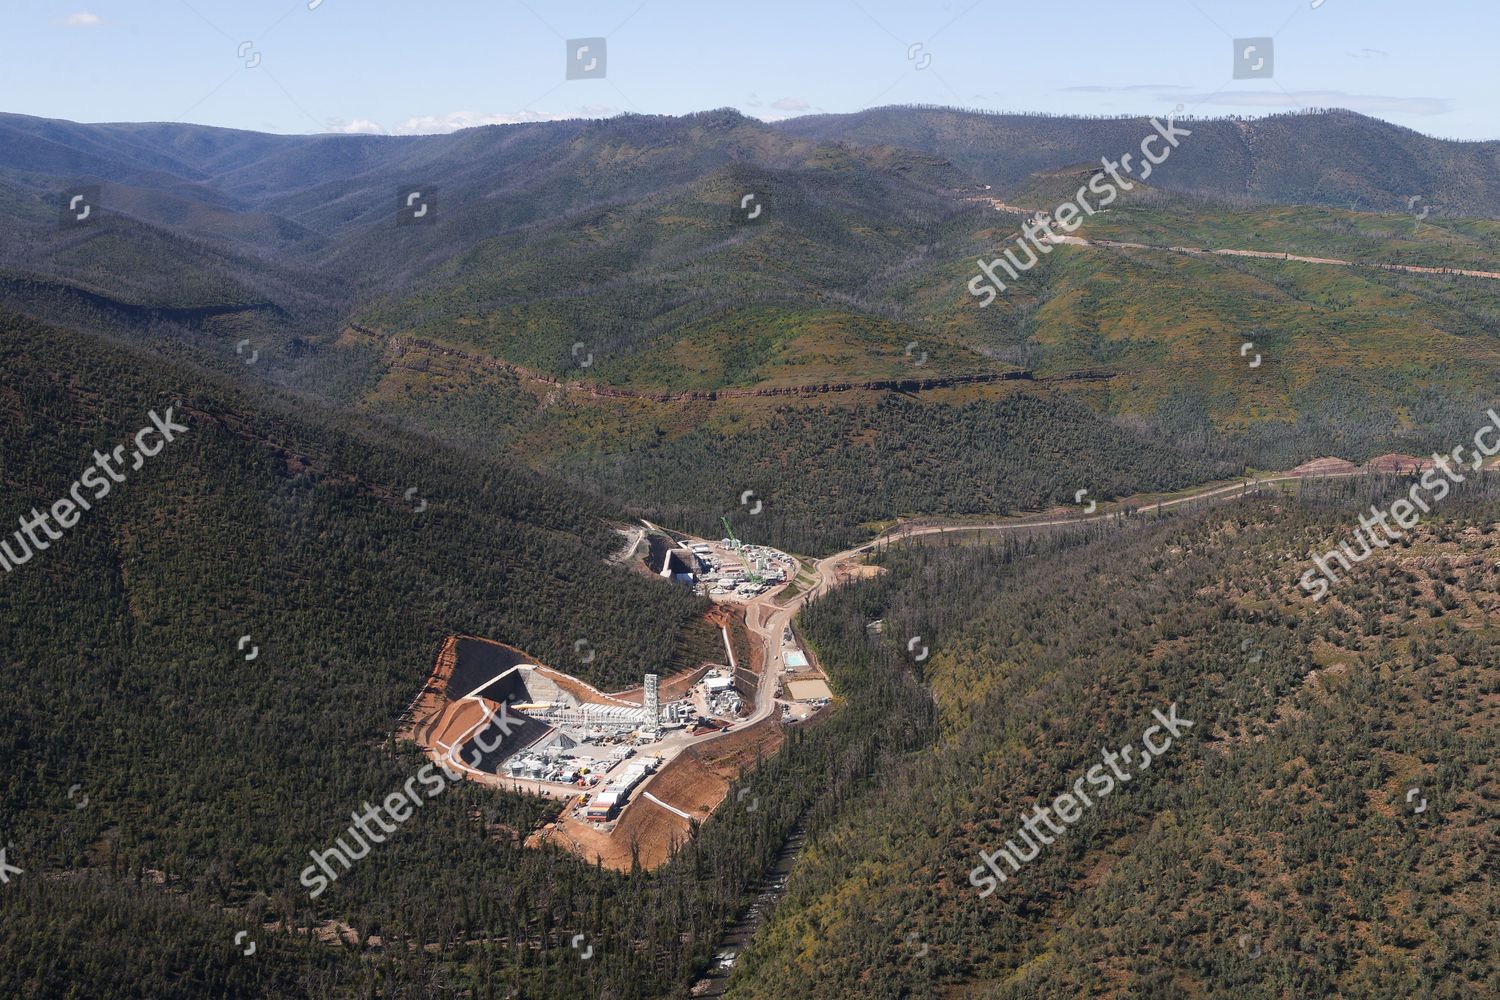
xmin=0 ymin=308 xmax=926 ymax=1000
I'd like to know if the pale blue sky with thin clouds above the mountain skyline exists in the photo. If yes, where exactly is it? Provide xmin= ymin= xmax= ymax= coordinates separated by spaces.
xmin=0 ymin=0 xmax=1500 ymax=139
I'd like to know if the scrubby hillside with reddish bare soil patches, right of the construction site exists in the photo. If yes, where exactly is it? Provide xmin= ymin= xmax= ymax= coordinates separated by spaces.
xmin=729 ymin=481 xmax=1500 ymax=1000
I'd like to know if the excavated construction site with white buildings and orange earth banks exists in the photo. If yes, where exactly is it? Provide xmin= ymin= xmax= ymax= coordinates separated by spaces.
xmin=398 ymin=522 xmax=833 ymax=868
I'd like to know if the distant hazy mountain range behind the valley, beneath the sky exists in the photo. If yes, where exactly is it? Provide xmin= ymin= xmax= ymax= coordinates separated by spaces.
xmin=0 ymin=108 xmax=1500 ymax=552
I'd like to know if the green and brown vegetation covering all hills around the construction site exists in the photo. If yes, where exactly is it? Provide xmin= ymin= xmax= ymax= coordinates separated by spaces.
xmin=0 ymin=103 xmax=1500 ymax=1000
